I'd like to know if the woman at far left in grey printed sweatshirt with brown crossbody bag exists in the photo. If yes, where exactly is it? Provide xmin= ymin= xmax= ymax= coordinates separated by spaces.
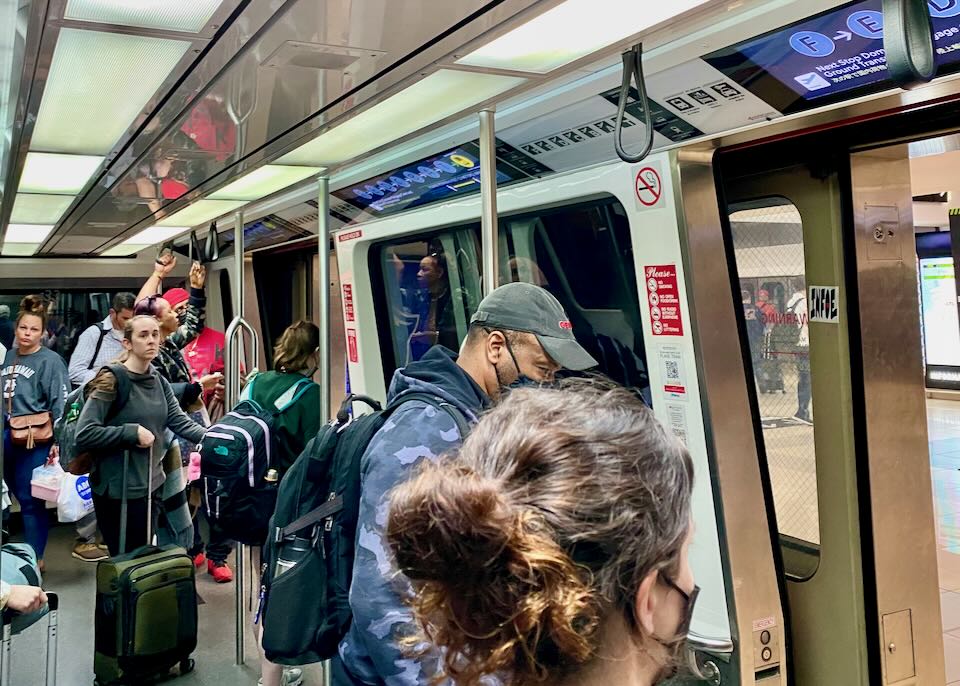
xmin=0 ymin=295 xmax=67 ymax=570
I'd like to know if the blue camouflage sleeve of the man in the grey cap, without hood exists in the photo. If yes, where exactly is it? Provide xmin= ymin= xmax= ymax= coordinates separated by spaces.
xmin=340 ymin=401 xmax=460 ymax=686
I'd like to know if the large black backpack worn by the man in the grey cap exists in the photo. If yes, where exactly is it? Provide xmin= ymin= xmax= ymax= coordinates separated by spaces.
xmin=257 ymin=393 xmax=470 ymax=665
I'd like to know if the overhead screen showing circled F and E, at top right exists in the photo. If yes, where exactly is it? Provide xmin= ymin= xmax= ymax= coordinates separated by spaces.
xmin=703 ymin=0 xmax=960 ymax=114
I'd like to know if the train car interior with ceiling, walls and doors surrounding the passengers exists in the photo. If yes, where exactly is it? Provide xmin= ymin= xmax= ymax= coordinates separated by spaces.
xmin=0 ymin=0 xmax=960 ymax=686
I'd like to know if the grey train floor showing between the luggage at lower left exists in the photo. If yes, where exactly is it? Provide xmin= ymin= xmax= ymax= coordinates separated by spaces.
xmin=3 ymin=524 xmax=323 ymax=686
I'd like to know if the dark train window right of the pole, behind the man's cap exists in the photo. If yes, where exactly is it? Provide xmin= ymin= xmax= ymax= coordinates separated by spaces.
xmin=500 ymin=198 xmax=650 ymax=404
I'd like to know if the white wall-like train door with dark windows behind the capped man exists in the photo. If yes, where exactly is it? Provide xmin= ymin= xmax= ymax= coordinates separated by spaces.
xmin=335 ymin=156 xmax=787 ymax=686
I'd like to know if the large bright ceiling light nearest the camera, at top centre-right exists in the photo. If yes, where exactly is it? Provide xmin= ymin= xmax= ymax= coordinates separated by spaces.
xmin=457 ymin=0 xmax=707 ymax=74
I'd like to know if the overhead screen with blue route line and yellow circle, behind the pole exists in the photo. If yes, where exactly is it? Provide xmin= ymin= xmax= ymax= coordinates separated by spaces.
xmin=332 ymin=140 xmax=551 ymax=222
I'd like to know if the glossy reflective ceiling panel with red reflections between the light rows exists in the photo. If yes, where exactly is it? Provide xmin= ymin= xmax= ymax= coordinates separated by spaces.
xmin=44 ymin=0 xmax=533 ymax=253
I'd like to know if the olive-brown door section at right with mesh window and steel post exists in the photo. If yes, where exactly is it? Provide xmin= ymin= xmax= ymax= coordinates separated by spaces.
xmin=680 ymin=138 xmax=945 ymax=686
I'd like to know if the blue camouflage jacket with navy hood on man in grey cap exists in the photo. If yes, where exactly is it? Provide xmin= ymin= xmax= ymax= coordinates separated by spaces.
xmin=338 ymin=346 xmax=490 ymax=686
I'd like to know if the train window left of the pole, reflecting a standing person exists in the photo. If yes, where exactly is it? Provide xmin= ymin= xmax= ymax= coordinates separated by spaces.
xmin=372 ymin=225 xmax=480 ymax=379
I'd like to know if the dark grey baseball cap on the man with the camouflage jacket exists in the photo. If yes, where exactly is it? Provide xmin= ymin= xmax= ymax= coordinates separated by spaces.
xmin=470 ymin=283 xmax=597 ymax=371
